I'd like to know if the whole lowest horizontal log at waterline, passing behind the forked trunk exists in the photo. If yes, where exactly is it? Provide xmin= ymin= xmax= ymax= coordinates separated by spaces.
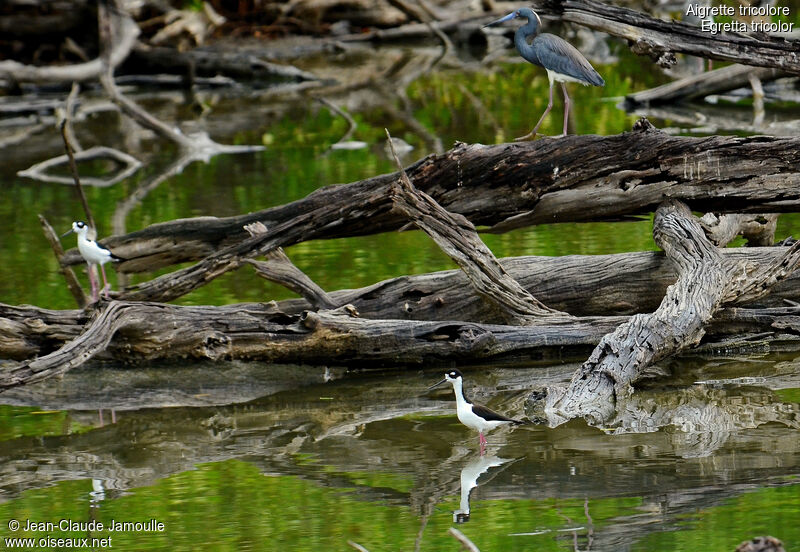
xmin=0 ymin=302 xmax=800 ymax=389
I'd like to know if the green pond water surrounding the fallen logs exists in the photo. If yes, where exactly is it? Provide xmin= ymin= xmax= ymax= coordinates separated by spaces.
xmin=0 ymin=33 xmax=800 ymax=552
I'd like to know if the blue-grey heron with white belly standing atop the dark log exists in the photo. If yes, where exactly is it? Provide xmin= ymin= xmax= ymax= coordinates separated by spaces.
xmin=484 ymin=8 xmax=606 ymax=140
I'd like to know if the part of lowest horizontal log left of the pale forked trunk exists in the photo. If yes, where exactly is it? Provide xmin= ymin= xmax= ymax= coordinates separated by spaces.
xmin=0 ymin=301 xmax=624 ymax=389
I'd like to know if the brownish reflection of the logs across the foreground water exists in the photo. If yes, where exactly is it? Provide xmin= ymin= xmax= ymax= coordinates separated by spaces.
xmin=0 ymin=366 xmax=800 ymax=545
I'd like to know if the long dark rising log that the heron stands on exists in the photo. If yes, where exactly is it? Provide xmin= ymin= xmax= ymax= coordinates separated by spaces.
xmin=64 ymin=123 xmax=800 ymax=278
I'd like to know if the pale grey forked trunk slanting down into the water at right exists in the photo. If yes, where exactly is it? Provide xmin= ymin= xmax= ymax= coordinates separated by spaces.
xmin=537 ymin=200 xmax=800 ymax=424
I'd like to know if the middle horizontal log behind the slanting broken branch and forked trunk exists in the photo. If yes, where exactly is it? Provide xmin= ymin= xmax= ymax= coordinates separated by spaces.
xmin=278 ymin=247 xmax=800 ymax=323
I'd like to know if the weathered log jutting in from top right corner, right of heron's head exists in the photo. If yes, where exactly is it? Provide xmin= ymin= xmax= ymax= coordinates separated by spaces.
xmin=534 ymin=0 xmax=800 ymax=74
